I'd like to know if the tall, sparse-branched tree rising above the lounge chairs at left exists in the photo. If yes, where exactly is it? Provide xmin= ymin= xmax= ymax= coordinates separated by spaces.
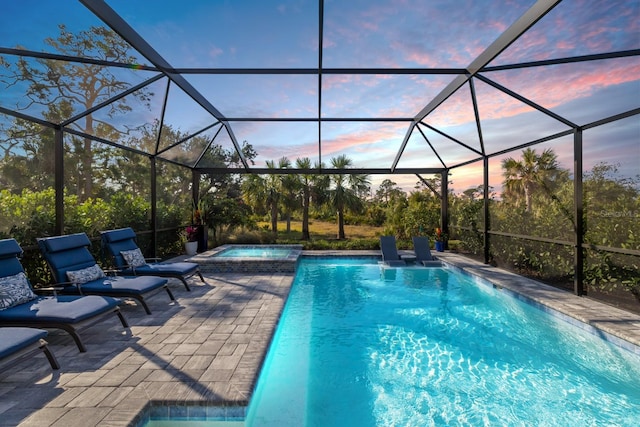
xmin=0 ymin=24 xmax=149 ymax=200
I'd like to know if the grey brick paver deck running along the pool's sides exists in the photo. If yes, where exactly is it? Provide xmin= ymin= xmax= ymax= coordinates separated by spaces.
xmin=0 ymin=251 xmax=640 ymax=427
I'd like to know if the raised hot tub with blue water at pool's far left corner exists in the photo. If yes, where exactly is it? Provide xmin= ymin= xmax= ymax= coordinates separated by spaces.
xmin=189 ymin=245 xmax=302 ymax=273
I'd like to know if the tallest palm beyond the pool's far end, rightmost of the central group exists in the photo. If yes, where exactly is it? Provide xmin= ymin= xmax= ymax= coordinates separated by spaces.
xmin=330 ymin=154 xmax=370 ymax=240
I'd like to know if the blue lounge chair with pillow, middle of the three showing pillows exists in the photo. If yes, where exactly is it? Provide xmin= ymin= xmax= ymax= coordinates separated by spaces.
xmin=37 ymin=233 xmax=175 ymax=314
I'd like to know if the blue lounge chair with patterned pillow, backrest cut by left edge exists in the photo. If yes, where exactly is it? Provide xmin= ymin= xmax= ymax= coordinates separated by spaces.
xmin=0 ymin=239 xmax=129 ymax=352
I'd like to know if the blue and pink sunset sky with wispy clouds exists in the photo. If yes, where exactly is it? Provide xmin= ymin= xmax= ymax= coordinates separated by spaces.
xmin=0 ymin=0 xmax=640 ymax=191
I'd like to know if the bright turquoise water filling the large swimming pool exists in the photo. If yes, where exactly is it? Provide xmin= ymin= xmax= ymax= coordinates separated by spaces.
xmin=246 ymin=259 xmax=640 ymax=427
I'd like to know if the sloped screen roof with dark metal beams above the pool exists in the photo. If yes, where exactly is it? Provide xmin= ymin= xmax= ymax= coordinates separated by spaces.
xmin=0 ymin=0 xmax=640 ymax=182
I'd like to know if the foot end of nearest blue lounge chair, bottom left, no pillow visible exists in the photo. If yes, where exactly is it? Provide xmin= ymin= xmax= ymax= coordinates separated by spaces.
xmin=0 ymin=328 xmax=60 ymax=371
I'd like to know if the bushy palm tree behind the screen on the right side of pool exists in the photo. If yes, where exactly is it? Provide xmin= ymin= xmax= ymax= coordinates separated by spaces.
xmin=502 ymin=148 xmax=561 ymax=212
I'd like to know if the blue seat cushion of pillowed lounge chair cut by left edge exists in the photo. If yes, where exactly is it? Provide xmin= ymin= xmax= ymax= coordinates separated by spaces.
xmin=0 ymin=295 xmax=120 ymax=324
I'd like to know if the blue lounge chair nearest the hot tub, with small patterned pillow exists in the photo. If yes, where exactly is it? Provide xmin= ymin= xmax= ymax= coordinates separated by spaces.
xmin=100 ymin=227 xmax=204 ymax=291
